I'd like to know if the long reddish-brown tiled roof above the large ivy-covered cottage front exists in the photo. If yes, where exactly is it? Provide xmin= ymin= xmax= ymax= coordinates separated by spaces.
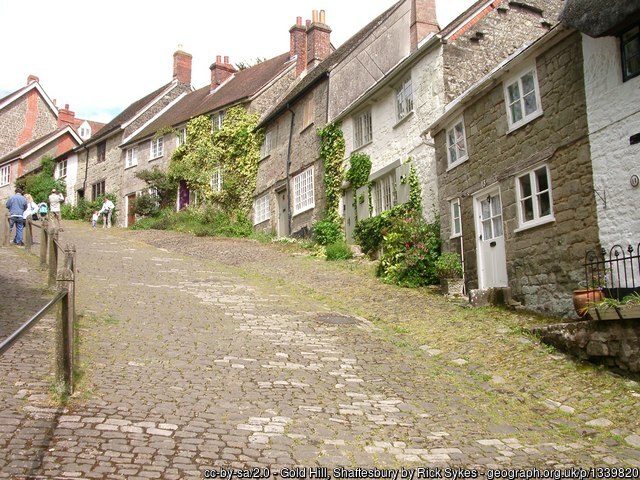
xmin=124 ymin=52 xmax=293 ymax=144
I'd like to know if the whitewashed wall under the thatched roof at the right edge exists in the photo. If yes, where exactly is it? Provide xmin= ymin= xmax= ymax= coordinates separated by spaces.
xmin=582 ymin=35 xmax=640 ymax=249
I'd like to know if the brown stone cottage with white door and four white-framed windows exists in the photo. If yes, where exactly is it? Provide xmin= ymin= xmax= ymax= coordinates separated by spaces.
xmin=429 ymin=25 xmax=598 ymax=316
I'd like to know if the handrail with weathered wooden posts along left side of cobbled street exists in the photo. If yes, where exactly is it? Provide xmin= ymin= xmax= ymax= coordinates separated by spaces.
xmin=0 ymin=212 xmax=76 ymax=394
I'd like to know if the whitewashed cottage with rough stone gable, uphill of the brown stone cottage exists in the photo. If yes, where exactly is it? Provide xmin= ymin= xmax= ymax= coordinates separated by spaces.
xmin=330 ymin=0 xmax=559 ymax=242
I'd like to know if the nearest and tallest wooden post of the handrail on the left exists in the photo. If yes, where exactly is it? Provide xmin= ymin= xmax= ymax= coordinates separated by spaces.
xmin=56 ymin=248 xmax=75 ymax=395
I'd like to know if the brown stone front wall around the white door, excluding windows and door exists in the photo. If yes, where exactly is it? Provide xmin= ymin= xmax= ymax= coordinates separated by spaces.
xmin=435 ymin=29 xmax=598 ymax=316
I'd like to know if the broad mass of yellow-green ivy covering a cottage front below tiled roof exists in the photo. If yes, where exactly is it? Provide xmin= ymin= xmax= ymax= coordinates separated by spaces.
xmin=169 ymin=105 xmax=264 ymax=213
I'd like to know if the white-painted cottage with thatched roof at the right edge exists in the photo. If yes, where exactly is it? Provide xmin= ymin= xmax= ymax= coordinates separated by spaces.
xmin=560 ymin=0 xmax=640 ymax=253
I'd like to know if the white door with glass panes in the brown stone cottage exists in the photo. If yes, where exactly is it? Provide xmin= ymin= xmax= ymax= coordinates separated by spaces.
xmin=474 ymin=189 xmax=507 ymax=289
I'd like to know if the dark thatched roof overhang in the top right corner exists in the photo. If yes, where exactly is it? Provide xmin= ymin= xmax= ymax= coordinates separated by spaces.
xmin=560 ymin=0 xmax=640 ymax=38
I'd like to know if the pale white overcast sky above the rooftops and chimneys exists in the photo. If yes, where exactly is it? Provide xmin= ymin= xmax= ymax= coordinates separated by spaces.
xmin=0 ymin=0 xmax=473 ymax=122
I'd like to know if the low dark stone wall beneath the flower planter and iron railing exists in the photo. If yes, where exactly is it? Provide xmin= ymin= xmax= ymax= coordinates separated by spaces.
xmin=531 ymin=319 xmax=640 ymax=373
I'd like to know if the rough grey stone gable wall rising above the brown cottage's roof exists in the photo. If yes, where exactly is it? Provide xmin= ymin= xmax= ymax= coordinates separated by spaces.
xmin=444 ymin=0 xmax=562 ymax=103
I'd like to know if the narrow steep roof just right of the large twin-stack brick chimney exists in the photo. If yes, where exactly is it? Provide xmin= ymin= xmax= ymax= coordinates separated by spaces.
xmin=258 ymin=0 xmax=404 ymax=128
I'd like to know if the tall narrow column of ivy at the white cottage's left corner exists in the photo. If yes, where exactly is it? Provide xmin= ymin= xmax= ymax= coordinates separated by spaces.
xmin=317 ymin=123 xmax=345 ymax=225
